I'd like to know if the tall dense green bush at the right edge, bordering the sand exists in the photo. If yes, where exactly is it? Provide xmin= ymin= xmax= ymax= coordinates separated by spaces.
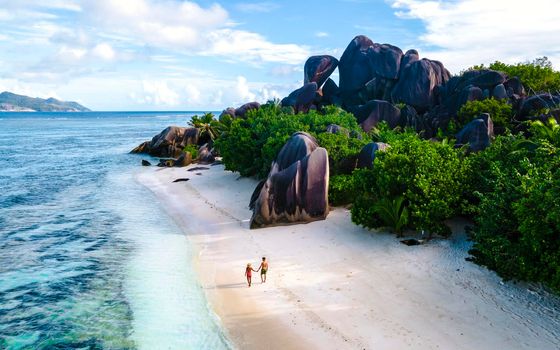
xmin=471 ymin=124 xmax=560 ymax=291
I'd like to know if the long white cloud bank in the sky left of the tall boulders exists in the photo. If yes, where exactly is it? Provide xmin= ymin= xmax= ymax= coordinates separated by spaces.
xmin=86 ymin=0 xmax=309 ymax=64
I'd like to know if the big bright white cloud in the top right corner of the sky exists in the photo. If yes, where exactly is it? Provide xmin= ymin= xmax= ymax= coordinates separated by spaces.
xmin=392 ymin=0 xmax=560 ymax=72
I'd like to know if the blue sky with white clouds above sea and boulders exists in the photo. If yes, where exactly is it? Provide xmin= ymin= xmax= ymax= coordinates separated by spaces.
xmin=0 ymin=0 xmax=560 ymax=111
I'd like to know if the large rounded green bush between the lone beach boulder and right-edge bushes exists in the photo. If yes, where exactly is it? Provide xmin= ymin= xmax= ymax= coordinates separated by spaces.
xmin=352 ymin=132 xmax=469 ymax=235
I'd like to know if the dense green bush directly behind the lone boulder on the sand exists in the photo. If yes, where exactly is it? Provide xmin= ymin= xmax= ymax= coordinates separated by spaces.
xmin=215 ymin=104 xmax=365 ymax=178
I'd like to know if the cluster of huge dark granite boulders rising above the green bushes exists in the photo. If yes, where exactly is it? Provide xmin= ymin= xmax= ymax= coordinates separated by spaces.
xmin=281 ymin=35 xmax=560 ymax=150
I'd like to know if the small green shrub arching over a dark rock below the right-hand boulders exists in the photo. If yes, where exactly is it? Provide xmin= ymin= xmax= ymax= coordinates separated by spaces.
xmin=457 ymin=98 xmax=513 ymax=128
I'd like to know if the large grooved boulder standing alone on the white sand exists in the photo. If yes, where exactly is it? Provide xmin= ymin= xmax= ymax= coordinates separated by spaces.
xmin=249 ymin=132 xmax=329 ymax=228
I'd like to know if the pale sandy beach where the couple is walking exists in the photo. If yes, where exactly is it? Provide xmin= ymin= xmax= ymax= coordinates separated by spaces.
xmin=138 ymin=165 xmax=560 ymax=350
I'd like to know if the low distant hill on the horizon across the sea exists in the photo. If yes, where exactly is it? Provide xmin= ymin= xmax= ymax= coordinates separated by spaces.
xmin=0 ymin=91 xmax=90 ymax=112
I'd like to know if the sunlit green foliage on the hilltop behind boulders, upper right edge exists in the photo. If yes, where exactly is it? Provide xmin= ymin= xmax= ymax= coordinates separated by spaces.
xmin=473 ymin=57 xmax=560 ymax=94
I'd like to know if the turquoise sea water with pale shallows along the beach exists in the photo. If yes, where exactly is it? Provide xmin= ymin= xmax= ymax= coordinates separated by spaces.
xmin=0 ymin=112 xmax=229 ymax=349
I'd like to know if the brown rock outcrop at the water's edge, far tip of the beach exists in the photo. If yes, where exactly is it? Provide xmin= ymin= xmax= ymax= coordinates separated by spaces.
xmin=131 ymin=126 xmax=198 ymax=158
